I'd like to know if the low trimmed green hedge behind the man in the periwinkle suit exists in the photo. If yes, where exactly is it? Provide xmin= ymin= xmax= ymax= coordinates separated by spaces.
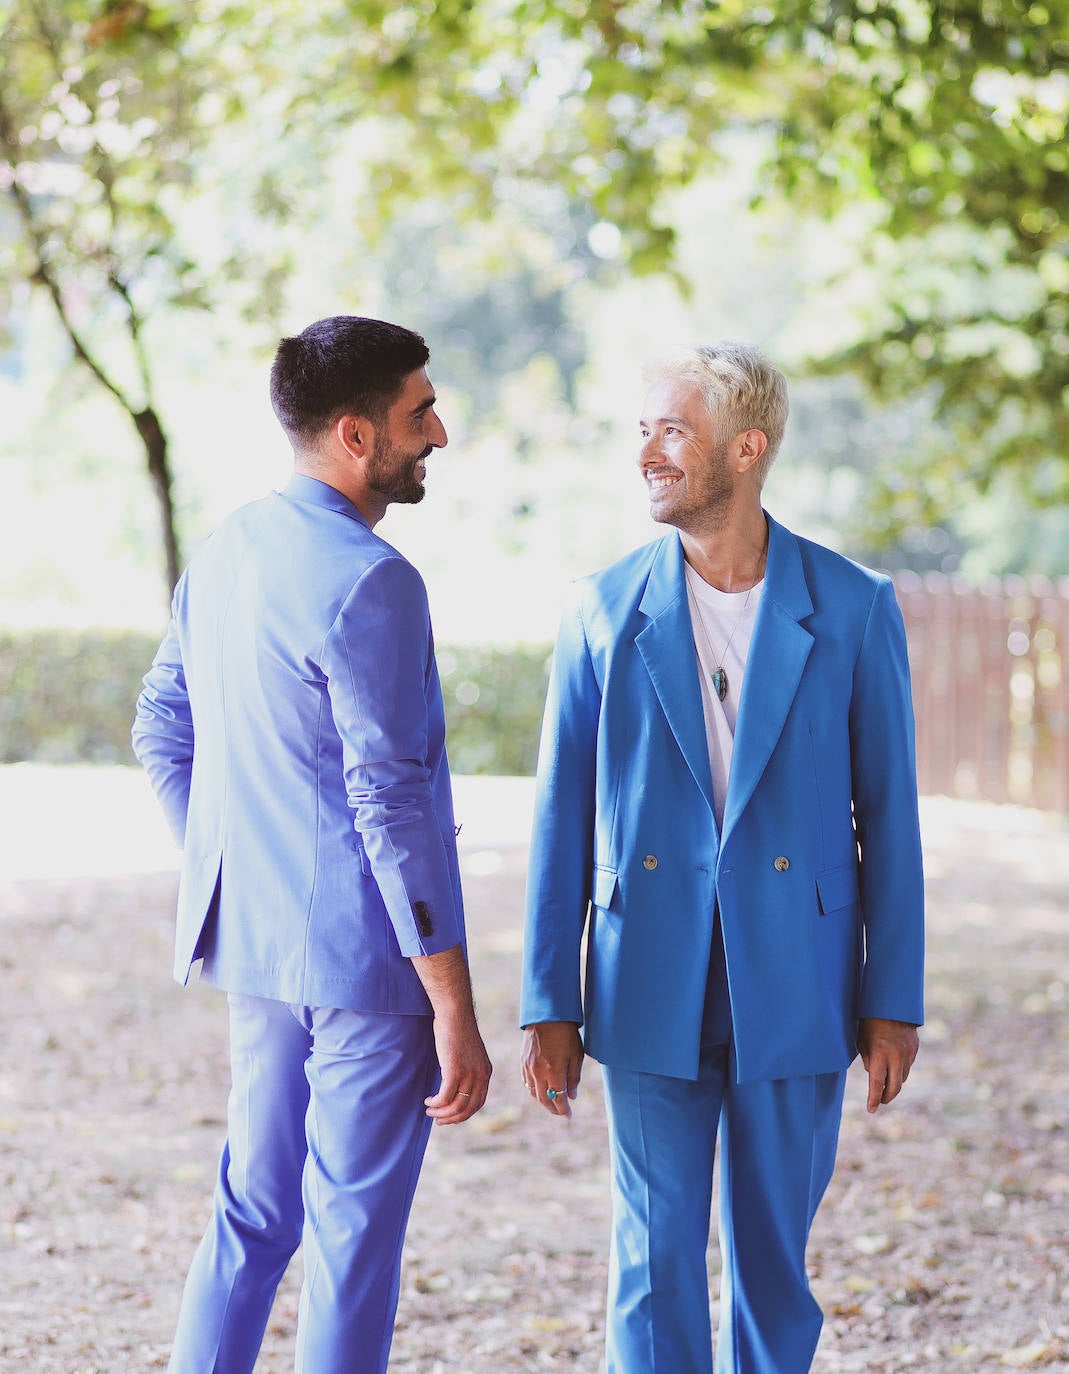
xmin=0 ymin=629 xmax=550 ymax=775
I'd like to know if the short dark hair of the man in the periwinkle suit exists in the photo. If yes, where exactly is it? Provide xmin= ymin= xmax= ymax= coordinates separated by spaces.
xmin=271 ymin=315 xmax=430 ymax=447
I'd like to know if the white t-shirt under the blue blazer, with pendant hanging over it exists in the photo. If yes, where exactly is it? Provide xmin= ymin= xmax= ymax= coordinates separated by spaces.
xmin=686 ymin=563 xmax=764 ymax=829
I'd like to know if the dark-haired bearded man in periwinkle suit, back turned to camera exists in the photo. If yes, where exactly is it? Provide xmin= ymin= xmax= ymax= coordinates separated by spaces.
xmin=133 ymin=316 xmax=491 ymax=1374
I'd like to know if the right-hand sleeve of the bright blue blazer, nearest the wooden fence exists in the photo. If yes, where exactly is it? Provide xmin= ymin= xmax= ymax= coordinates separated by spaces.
xmin=851 ymin=578 xmax=925 ymax=1025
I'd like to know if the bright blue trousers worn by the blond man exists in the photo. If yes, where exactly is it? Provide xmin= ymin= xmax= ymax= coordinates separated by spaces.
xmin=603 ymin=932 xmax=846 ymax=1374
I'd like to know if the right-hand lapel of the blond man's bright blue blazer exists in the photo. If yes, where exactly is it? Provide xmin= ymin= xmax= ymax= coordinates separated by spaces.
xmin=723 ymin=517 xmax=813 ymax=840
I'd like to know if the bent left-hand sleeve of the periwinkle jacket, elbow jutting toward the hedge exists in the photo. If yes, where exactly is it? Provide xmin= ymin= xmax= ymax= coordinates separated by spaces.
xmin=132 ymin=580 xmax=194 ymax=846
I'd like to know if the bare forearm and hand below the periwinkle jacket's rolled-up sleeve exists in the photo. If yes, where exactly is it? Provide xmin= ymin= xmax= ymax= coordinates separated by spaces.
xmin=412 ymin=945 xmax=493 ymax=1125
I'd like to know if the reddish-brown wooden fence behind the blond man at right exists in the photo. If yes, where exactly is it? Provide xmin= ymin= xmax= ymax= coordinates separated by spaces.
xmin=894 ymin=573 xmax=1069 ymax=812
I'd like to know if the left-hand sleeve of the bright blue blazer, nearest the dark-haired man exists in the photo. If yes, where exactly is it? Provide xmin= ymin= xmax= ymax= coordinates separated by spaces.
xmin=519 ymin=585 xmax=602 ymax=1025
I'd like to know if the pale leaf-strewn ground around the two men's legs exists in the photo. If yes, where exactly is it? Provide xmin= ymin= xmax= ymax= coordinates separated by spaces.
xmin=0 ymin=798 xmax=1069 ymax=1374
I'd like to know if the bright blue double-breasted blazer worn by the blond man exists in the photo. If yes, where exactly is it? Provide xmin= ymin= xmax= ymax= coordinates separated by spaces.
xmin=521 ymin=518 xmax=923 ymax=1081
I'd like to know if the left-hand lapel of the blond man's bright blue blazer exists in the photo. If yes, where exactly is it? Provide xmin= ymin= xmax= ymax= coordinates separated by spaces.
xmin=635 ymin=534 xmax=713 ymax=812
